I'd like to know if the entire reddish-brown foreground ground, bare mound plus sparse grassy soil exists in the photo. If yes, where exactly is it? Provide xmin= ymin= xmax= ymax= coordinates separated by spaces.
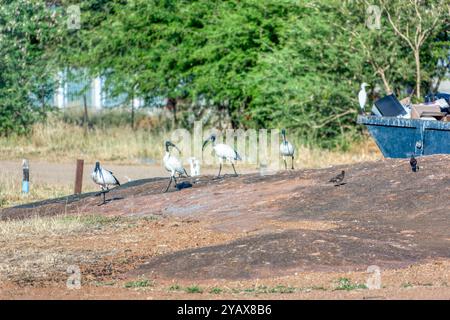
xmin=0 ymin=156 xmax=450 ymax=299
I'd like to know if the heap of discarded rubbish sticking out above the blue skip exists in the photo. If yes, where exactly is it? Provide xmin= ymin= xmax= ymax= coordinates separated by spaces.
xmin=372 ymin=93 xmax=450 ymax=122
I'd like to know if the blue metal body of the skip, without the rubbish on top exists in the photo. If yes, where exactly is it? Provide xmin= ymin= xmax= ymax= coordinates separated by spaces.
xmin=357 ymin=115 xmax=450 ymax=158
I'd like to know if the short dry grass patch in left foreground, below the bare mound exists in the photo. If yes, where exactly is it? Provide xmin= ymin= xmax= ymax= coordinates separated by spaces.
xmin=0 ymin=216 xmax=120 ymax=285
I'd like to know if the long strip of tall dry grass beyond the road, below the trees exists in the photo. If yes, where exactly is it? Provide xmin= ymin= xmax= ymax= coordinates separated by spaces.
xmin=0 ymin=119 xmax=381 ymax=168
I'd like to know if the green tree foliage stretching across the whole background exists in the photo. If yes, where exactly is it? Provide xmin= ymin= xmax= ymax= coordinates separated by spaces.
xmin=0 ymin=0 xmax=450 ymax=147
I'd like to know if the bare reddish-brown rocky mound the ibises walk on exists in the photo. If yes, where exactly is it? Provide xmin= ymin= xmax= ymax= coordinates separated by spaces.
xmin=0 ymin=156 xmax=450 ymax=279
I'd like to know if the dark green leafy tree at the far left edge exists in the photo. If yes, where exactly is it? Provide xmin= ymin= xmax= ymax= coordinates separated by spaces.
xmin=0 ymin=0 xmax=59 ymax=135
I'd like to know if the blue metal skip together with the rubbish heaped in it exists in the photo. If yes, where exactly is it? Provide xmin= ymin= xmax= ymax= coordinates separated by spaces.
xmin=357 ymin=90 xmax=450 ymax=158
